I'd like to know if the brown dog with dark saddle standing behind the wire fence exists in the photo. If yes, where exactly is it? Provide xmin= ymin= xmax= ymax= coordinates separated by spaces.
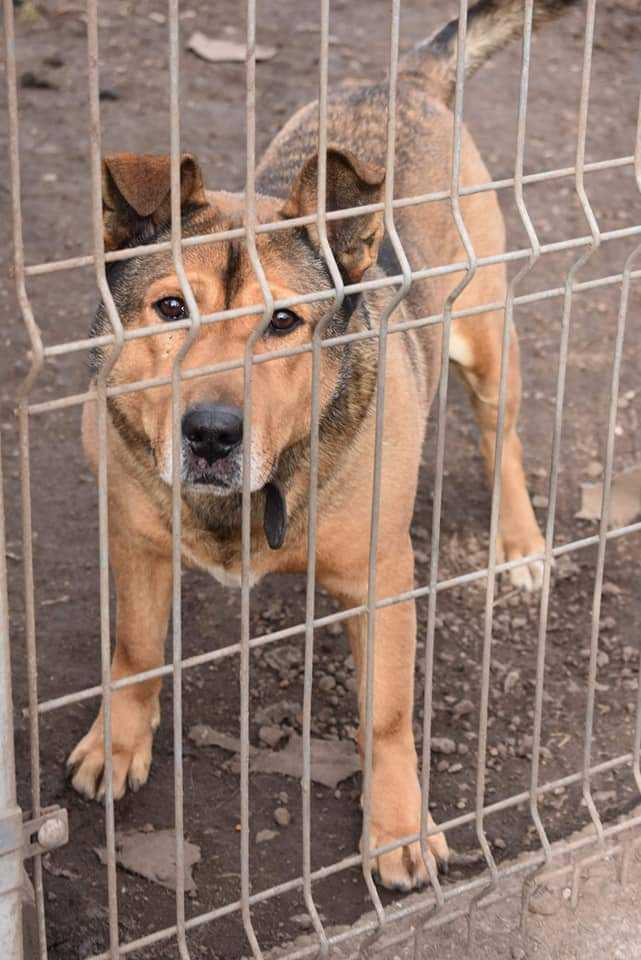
xmin=69 ymin=0 xmax=571 ymax=890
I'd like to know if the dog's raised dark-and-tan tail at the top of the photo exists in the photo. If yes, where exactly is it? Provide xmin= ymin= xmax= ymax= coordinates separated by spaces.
xmin=400 ymin=0 xmax=580 ymax=103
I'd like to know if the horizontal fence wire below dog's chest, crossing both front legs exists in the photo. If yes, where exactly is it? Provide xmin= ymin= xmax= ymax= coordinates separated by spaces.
xmin=28 ymin=521 xmax=641 ymax=716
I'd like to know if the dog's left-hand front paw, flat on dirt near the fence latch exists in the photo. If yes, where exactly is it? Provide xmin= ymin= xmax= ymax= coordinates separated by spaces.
xmin=67 ymin=694 xmax=160 ymax=801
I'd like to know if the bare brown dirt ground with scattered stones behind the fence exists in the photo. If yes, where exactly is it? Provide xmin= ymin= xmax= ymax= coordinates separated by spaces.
xmin=0 ymin=0 xmax=641 ymax=960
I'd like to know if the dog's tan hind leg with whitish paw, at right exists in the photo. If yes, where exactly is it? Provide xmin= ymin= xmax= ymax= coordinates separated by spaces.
xmin=450 ymin=297 xmax=543 ymax=590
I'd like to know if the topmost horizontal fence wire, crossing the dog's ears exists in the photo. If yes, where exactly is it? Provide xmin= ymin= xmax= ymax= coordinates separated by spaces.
xmin=25 ymin=156 xmax=634 ymax=277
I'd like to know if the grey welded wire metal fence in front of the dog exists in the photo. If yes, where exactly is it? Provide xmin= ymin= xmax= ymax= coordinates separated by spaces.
xmin=0 ymin=0 xmax=641 ymax=960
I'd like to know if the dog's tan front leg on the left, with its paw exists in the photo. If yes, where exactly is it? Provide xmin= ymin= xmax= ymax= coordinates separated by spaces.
xmin=67 ymin=536 xmax=172 ymax=800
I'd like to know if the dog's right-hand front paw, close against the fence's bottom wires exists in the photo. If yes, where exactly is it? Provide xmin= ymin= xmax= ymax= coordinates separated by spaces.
xmin=361 ymin=770 xmax=449 ymax=893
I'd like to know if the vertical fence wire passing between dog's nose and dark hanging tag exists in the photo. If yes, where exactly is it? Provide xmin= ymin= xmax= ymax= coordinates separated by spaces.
xmin=240 ymin=0 xmax=274 ymax=960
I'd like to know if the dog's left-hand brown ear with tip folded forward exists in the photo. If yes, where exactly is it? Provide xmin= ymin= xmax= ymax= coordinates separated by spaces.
xmin=102 ymin=153 xmax=207 ymax=250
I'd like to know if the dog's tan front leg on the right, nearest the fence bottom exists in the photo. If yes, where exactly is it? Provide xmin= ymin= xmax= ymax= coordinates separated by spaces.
xmin=324 ymin=537 xmax=448 ymax=890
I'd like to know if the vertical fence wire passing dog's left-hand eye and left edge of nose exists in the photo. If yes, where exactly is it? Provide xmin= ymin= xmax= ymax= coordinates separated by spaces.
xmin=168 ymin=0 xmax=201 ymax=960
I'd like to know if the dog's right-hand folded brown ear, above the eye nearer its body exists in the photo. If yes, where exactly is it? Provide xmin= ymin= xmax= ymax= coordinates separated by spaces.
xmin=283 ymin=147 xmax=385 ymax=283
